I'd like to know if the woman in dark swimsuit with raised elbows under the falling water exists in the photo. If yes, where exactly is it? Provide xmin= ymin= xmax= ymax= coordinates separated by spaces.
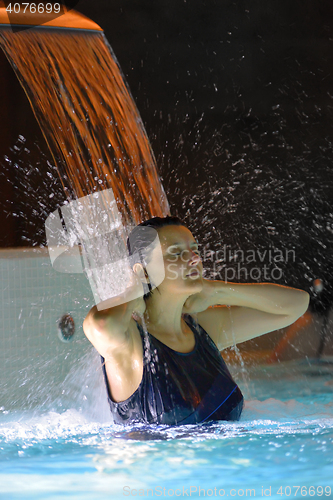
xmin=83 ymin=217 xmax=309 ymax=425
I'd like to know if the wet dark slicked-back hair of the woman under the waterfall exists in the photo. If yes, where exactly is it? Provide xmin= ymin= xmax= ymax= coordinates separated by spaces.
xmin=127 ymin=215 xmax=187 ymax=300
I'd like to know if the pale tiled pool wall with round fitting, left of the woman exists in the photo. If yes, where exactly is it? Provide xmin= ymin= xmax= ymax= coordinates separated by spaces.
xmin=0 ymin=248 xmax=100 ymax=410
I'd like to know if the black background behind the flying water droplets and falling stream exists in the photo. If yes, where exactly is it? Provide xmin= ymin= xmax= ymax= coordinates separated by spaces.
xmin=0 ymin=0 xmax=333 ymax=306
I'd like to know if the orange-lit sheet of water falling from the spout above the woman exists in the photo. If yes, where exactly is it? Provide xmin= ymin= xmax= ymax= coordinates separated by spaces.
xmin=0 ymin=25 xmax=169 ymax=225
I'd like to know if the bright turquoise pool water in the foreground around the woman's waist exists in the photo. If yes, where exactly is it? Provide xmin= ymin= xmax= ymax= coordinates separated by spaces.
xmin=0 ymin=359 xmax=333 ymax=500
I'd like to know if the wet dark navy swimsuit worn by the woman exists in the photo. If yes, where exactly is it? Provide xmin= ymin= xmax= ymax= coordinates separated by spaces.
xmin=102 ymin=315 xmax=244 ymax=425
